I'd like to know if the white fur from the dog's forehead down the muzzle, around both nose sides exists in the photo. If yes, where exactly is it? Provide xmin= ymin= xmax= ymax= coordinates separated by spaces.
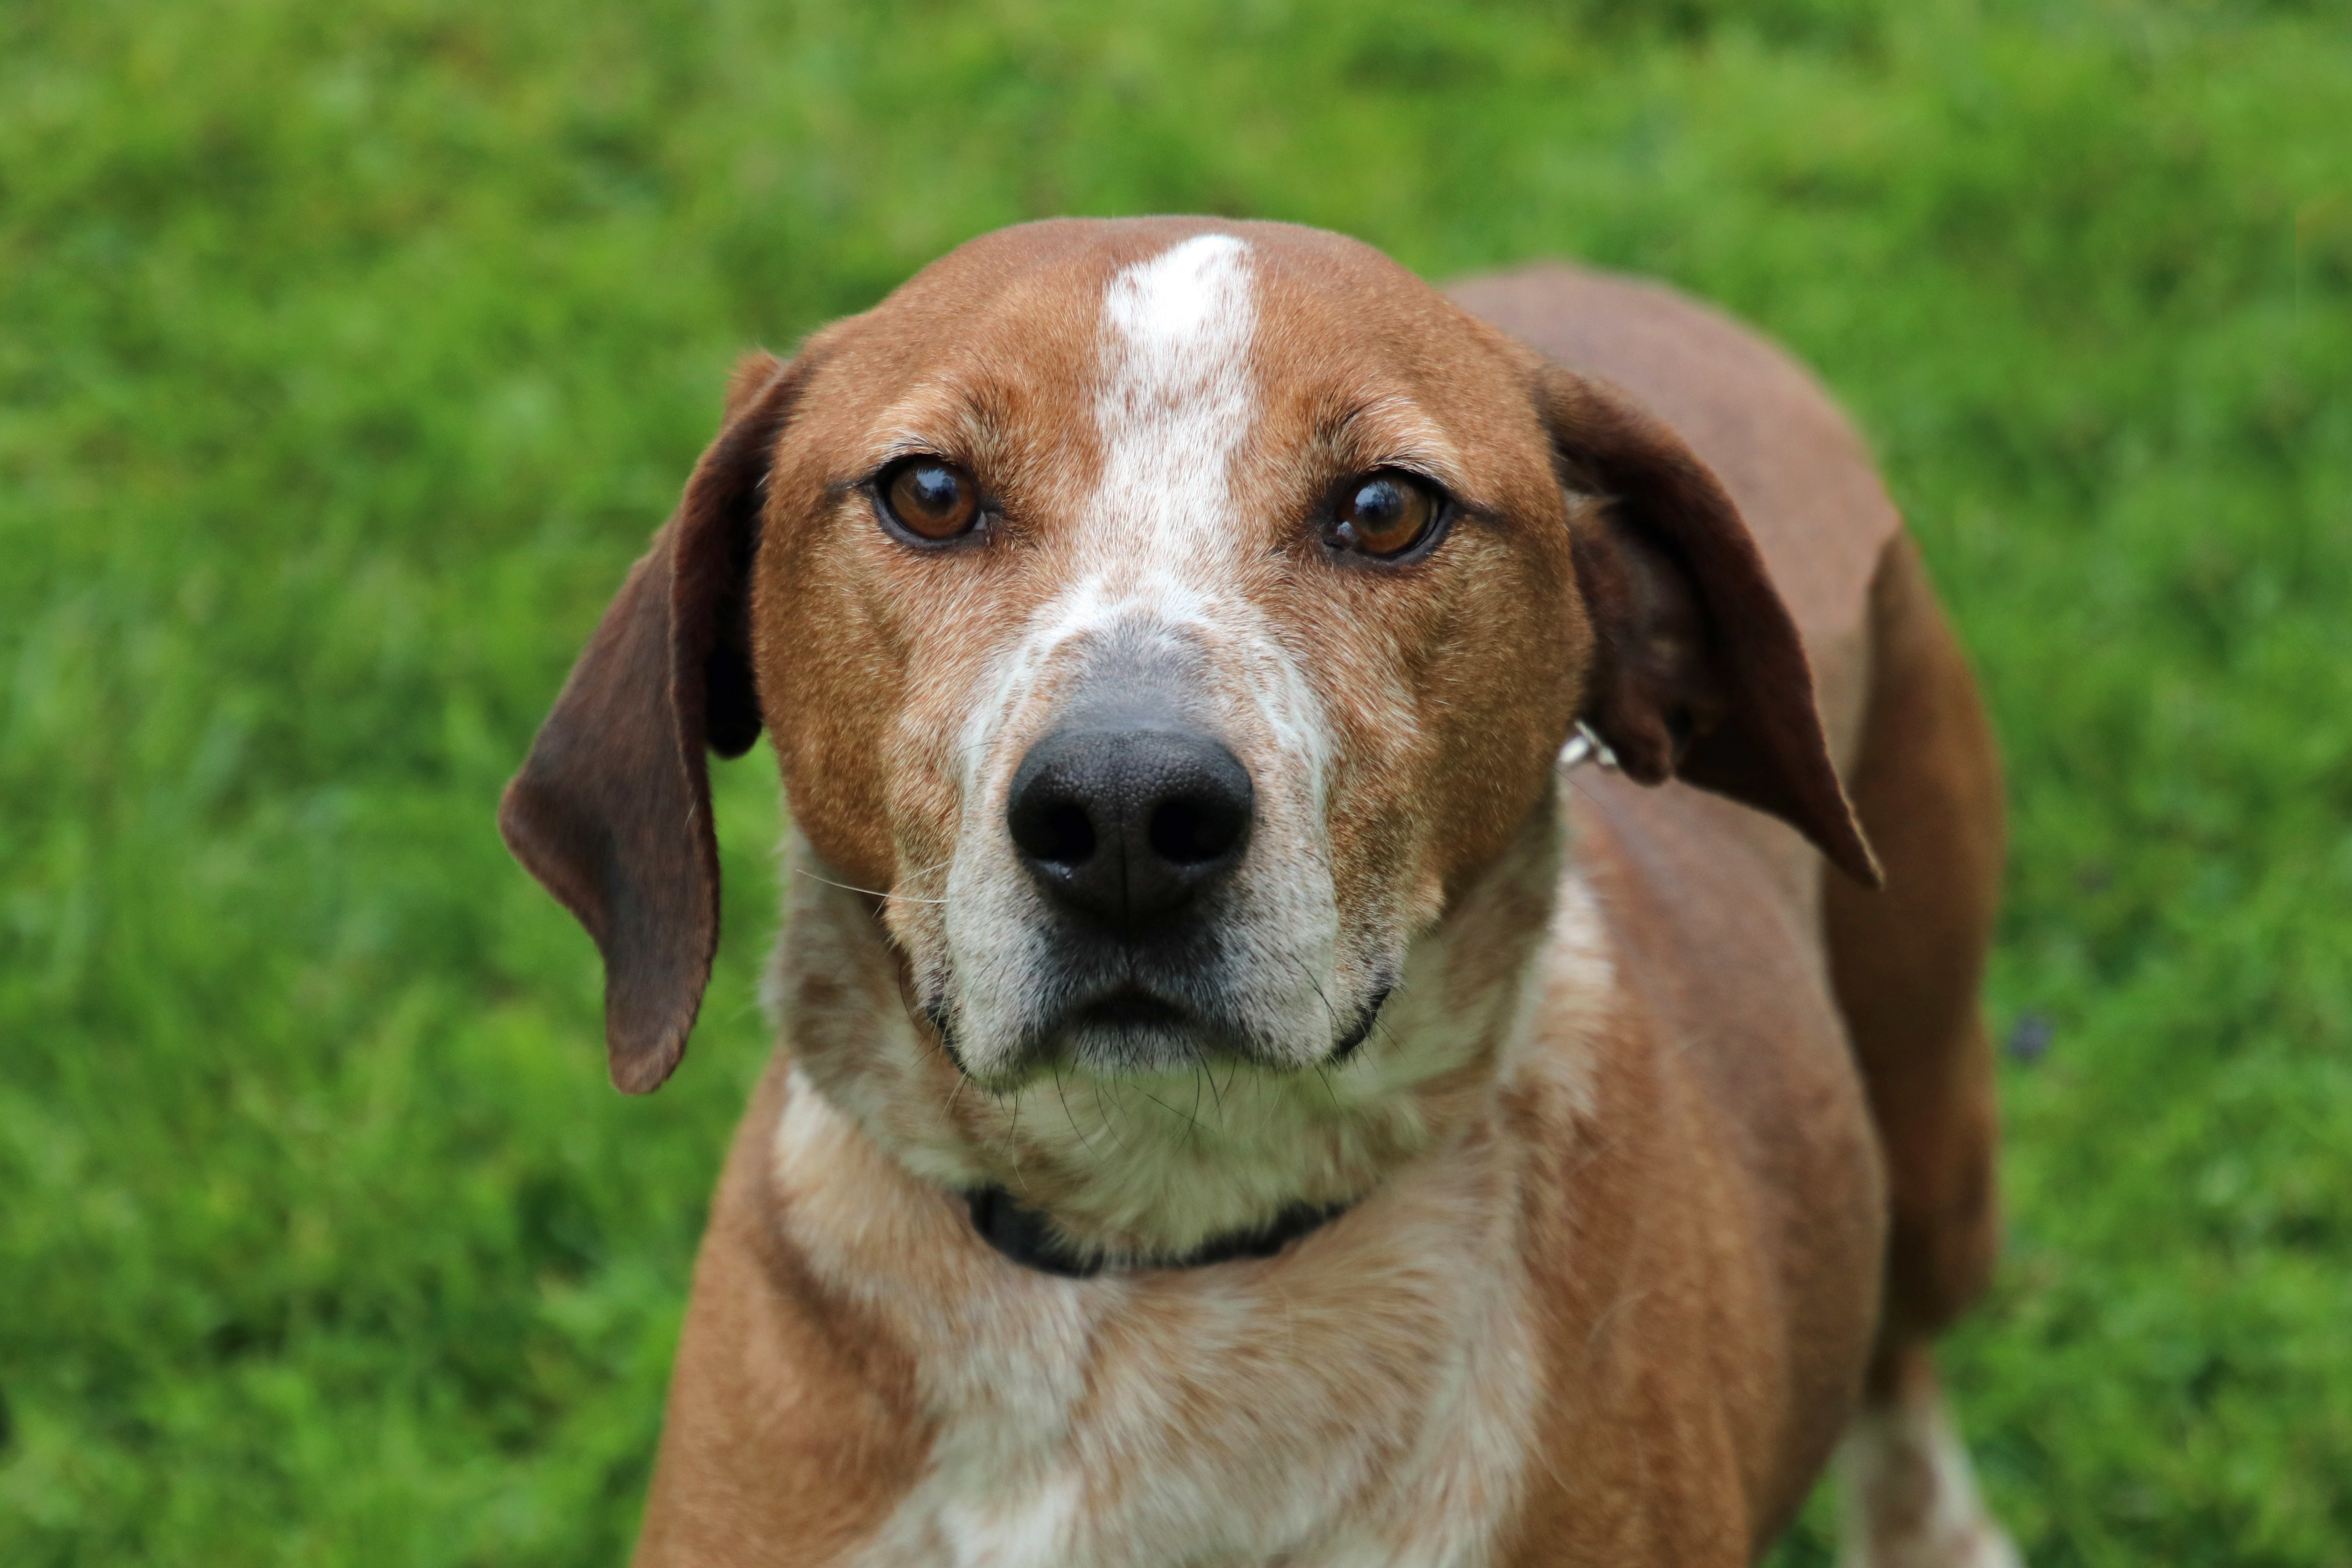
xmin=922 ymin=235 xmax=1371 ymax=1093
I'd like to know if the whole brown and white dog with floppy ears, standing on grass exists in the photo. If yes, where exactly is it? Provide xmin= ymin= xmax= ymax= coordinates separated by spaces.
xmin=501 ymin=219 xmax=2013 ymax=1568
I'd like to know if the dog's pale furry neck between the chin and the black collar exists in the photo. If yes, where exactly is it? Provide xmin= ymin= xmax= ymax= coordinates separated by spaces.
xmin=769 ymin=792 xmax=1566 ymax=1272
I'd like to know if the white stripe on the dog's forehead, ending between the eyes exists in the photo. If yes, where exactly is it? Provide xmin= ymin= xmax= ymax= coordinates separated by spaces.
xmin=1087 ymin=235 xmax=1258 ymax=576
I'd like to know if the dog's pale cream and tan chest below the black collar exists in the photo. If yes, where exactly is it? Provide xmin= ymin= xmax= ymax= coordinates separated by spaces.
xmin=779 ymin=1093 xmax=1541 ymax=1568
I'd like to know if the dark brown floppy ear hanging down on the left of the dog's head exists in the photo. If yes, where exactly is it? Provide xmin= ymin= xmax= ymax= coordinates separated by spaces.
xmin=499 ymin=353 xmax=800 ymax=1093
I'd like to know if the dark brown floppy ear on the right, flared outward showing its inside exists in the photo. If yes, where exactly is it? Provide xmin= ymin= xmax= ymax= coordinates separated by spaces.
xmin=1538 ymin=369 xmax=1882 ymax=886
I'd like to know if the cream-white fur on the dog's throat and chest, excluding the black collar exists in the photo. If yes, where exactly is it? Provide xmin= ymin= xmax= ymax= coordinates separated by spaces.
xmin=771 ymin=813 xmax=1613 ymax=1568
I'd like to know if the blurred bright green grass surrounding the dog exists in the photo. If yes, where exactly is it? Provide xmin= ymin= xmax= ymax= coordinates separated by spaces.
xmin=0 ymin=0 xmax=2352 ymax=1568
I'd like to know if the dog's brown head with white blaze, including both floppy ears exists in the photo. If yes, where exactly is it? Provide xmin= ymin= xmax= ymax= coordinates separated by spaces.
xmin=501 ymin=219 xmax=1872 ymax=1250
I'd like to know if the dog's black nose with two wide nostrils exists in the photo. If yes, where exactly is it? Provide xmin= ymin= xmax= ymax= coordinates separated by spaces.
xmin=1004 ymin=724 xmax=1254 ymax=924
